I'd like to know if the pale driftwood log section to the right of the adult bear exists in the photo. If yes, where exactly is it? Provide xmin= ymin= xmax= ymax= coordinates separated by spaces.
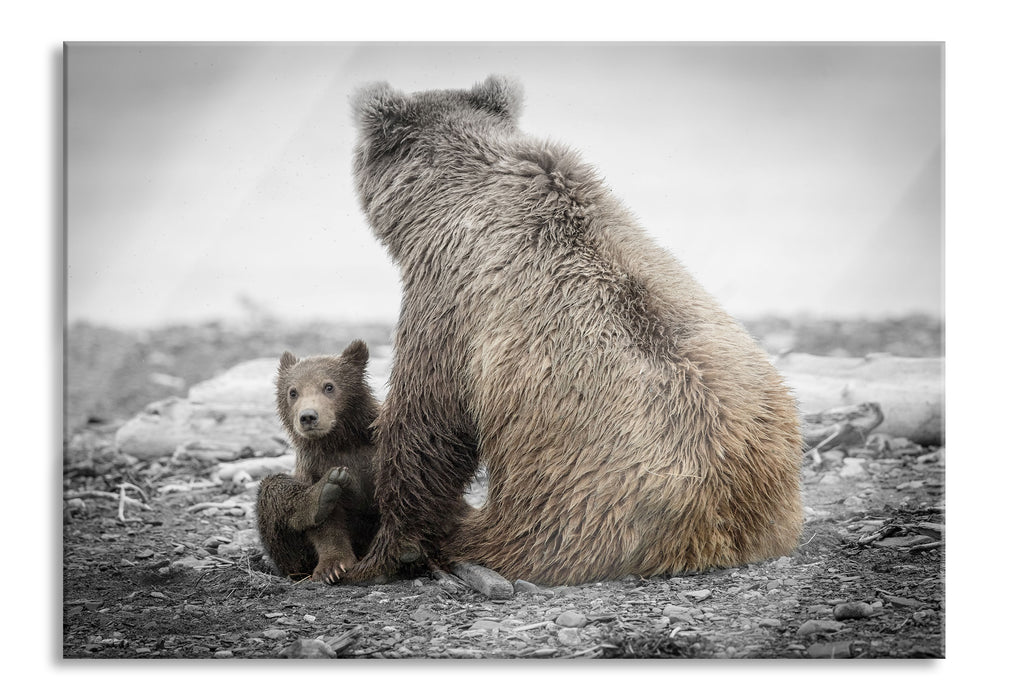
xmin=775 ymin=353 xmax=945 ymax=445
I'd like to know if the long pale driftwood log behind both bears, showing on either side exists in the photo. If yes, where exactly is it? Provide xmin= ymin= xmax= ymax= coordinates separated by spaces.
xmin=116 ymin=354 xmax=943 ymax=463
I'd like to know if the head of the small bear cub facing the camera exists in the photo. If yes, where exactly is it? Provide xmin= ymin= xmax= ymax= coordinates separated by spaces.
xmin=276 ymin=340 xmax=374 ymax=442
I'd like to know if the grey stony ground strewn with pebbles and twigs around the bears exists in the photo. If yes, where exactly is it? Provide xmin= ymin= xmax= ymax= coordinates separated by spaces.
xmin=62 ymin=319 xmax=945 ymax=659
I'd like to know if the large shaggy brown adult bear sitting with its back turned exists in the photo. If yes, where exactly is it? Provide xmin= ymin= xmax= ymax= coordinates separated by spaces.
xmin=349 ymin=77 xmax=802 ymax=584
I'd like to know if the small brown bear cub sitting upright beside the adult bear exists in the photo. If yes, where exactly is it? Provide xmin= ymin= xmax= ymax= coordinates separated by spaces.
xmin=256 ymin=340 xmax=378 ymax=583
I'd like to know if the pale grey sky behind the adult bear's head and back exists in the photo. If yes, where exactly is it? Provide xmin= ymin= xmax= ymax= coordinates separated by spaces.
xmin=66 ymin=43 xmax=943 ymax=328
